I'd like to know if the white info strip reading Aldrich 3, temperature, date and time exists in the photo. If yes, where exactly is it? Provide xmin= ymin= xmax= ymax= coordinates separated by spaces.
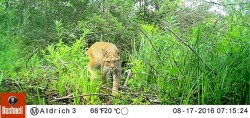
xmin=26 ymin=105 xmax=250 ymax=118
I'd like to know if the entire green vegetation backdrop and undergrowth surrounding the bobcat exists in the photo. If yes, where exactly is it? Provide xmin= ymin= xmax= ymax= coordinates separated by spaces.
xmin=0 ymin=0 xmax=250 ymax=105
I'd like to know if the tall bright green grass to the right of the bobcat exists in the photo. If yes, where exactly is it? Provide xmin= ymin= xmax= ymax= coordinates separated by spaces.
xmin=129 ymin=21 xmax=250 ymax=104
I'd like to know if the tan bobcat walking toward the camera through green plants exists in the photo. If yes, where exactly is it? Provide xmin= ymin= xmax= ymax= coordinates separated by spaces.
xmin=86 ymin=42 xmax=121 ymax=95
